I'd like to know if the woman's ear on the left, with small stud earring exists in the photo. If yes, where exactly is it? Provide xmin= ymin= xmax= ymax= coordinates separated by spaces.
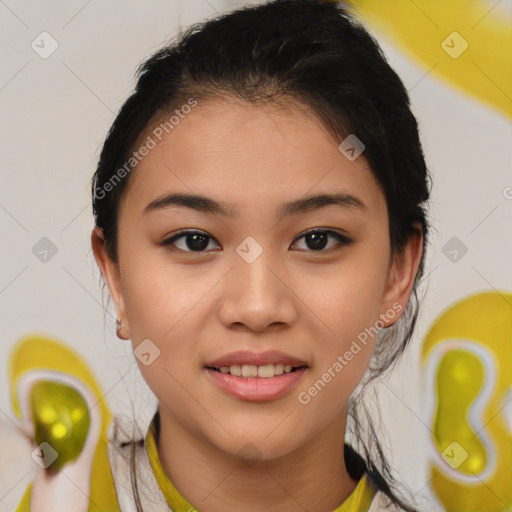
xmin=91 ymin=226 xmax=130 ymax=339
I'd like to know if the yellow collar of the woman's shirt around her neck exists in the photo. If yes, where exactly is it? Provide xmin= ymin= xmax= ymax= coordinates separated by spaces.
xmin=146 ymin=428 xmax=374 ymax=512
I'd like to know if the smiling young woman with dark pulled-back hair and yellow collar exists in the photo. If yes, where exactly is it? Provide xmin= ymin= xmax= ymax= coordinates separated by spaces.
xmin=26 ymin=0 xmax=429 ymax=512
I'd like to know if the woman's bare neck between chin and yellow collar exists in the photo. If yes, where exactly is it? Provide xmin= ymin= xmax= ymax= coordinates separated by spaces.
xmin=158 ymin=407 xmax=357 ymax=512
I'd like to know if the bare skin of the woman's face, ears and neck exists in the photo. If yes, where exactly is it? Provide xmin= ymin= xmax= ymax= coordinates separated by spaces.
xmin=92 ymin=98 xmax=422 ymax=512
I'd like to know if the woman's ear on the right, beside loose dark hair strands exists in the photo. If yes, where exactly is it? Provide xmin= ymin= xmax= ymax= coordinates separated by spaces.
xmin=381 ymin=223 xmax=423 ymax=327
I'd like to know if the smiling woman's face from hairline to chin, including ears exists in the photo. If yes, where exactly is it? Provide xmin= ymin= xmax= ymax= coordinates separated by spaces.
xmin=93 ymin=99 xmax=420 ymax=459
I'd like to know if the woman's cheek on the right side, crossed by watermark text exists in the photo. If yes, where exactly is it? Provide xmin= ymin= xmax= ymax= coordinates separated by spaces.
xmin=298 ymin=244 xmax=388 ymax=408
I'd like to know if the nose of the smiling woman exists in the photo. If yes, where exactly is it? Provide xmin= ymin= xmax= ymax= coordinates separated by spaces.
xmin=219 ymin=251 xmax=297 ymax=332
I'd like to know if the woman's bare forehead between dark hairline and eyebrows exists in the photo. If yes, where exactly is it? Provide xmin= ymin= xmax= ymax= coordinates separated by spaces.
xmin=118 ymin=98 xmax=384 ymax=217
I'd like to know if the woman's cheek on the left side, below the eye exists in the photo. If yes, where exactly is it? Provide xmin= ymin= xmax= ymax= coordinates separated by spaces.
xmin=120 ymin=261 xmax=210 ymax=398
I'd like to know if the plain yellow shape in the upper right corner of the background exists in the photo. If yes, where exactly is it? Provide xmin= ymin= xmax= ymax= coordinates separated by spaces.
xmin=351 ymin=0 xmax=512 ymax=118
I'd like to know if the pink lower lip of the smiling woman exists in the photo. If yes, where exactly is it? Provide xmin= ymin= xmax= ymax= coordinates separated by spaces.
xmin=205 ymin=367 xmax=307 ymax=402
